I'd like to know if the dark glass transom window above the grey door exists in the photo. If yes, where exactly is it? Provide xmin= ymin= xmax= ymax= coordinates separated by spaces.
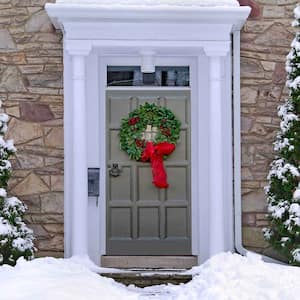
xmin=107 ymin=66 xmax=190 ymax=87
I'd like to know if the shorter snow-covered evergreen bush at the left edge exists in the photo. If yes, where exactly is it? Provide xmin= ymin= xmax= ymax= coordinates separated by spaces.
xmin=0 ymin=103 xmax=34 ymax=265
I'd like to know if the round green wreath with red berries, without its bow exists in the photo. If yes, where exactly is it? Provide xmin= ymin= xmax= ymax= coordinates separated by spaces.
xmin=120 ymin=103 xmax=181 ymax=161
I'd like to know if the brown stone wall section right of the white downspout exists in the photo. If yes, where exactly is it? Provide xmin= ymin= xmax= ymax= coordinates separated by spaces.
xmin=240 ymin=0 xmax=299 ymax=254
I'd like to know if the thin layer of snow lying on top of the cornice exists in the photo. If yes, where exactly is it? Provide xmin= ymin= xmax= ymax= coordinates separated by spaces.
xmin=56 ymin=0 xmax=239 ymax=7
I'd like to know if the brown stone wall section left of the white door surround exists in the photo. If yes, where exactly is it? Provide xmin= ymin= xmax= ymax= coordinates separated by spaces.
xmin=0 ymin=0 xmax=63 ymax=256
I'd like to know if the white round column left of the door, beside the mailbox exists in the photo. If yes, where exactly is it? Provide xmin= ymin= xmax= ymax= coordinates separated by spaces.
xmin=71 ymin=52 xmax=88 ymax=256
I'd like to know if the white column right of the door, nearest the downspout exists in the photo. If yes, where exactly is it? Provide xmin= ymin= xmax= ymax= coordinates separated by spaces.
xmin=205 ymin=45 xmax=229 ymax=256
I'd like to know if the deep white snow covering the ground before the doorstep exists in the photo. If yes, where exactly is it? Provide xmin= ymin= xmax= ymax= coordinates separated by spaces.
xmin=0 ymin=253 xmax=300 ymax=300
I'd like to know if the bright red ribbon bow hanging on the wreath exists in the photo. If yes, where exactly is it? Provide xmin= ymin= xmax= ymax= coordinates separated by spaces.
xmin=141 ymin=142 xmax=176 ymax=189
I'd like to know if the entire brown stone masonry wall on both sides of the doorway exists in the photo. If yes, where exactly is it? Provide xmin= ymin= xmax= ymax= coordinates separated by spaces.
xmin=0 ymin=0 xmax=298 ymax=256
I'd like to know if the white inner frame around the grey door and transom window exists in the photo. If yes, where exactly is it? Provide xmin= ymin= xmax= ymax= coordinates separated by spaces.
xmin=95 ymin=56 xmax=205 ymax=255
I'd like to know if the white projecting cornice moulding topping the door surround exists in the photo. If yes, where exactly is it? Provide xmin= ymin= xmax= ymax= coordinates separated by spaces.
xmin=45 ymin=3 xmax=251 ymax=30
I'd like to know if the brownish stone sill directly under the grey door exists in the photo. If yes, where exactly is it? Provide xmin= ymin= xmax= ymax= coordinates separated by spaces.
xmin=101 ymin=255 xmax=197 ymax=269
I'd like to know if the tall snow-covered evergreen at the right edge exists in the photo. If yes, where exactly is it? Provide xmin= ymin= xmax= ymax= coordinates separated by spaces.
xmin=264 ymin=5 xmax=300 ymax=266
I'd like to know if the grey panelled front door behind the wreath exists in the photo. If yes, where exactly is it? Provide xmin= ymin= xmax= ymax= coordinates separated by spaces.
xmin=106 ymin=90 xmax=191 ymax=255
